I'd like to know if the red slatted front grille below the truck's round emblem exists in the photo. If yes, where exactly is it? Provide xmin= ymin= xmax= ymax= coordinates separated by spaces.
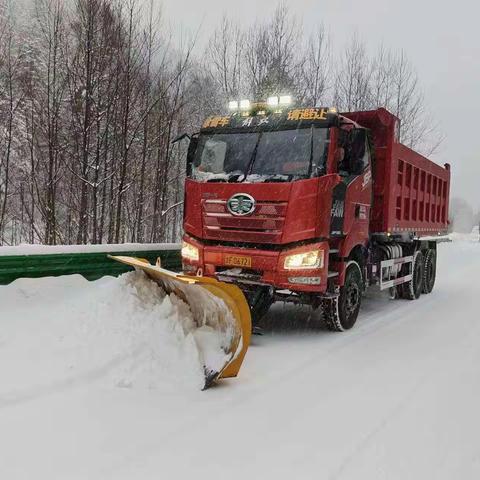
xmin=202 ymin=200 xmax=287 ymax=243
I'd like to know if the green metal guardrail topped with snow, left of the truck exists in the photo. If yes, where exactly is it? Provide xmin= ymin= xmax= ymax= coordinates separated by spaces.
xmin=0 ymin=248 xmax=182 ymax=285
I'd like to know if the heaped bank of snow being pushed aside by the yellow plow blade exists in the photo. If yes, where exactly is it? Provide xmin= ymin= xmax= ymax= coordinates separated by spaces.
xmin=0 ymin=272 xmax=232 ymax=392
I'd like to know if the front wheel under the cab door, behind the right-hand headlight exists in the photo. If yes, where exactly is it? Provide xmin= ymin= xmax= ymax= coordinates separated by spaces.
xmin=322 ymin=261 xmax=363 ymax=332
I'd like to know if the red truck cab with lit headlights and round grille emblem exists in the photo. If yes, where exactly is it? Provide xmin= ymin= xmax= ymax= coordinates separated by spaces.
xmin=183 ymin=101 xmax=372 ymax=320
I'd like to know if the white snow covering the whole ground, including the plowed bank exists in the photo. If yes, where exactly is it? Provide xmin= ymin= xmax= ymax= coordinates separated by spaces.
xmin=0 ymin=235 xmax=480 ymax=480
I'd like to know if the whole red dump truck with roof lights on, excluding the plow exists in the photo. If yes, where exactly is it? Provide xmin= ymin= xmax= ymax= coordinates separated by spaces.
xmin=182 ymin=102 xmax=450 ymax=331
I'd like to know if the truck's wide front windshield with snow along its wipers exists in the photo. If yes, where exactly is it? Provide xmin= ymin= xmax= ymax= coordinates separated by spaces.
xmin=192 ymin=127 xmax=328 ymax=182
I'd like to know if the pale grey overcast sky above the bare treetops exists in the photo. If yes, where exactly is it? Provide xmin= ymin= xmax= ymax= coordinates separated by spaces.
xmin=155 ymin=0 xmax=480 ymax=208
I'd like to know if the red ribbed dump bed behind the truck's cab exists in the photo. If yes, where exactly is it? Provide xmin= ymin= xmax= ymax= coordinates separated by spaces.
xmin=345 ymin=108 xmax=450 ymax=236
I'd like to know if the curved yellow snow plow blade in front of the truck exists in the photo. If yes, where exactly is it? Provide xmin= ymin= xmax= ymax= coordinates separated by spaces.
xmin=109 ymin=255 xmax=252 ymax=390
